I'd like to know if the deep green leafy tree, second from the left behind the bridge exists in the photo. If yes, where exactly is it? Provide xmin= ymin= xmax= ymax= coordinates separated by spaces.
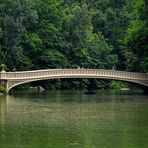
xmin=26 ymin=0 xmax=67 ymax=69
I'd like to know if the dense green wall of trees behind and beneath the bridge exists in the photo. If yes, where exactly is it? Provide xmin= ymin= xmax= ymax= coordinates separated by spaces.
xmin=0 ymin=0 xmax=148 ymax=88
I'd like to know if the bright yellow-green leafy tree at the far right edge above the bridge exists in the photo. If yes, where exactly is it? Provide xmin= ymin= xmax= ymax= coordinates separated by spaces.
xmin=124 ymin=0 xmax=148 ymax=71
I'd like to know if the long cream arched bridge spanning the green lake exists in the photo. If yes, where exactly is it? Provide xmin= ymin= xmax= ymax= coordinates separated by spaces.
xmin=0 ymin=69 xmax=148 ymax=91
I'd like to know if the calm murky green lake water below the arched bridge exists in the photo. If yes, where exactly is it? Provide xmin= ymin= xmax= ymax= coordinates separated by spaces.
xmin=0 ymin=91 xmax=148 ymax=148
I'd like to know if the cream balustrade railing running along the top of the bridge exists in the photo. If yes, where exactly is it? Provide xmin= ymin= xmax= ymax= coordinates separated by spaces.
xmin=0 ymin=69 xmax=148 ymax=79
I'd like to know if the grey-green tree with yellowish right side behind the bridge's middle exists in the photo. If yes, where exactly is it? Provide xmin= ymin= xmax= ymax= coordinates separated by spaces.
xmin=61 ymin=4 xmax=115 ymax=68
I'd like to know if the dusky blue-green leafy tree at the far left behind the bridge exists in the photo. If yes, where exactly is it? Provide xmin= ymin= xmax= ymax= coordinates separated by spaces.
xmin=0 ymin=0 xmax=37 ymax=70
